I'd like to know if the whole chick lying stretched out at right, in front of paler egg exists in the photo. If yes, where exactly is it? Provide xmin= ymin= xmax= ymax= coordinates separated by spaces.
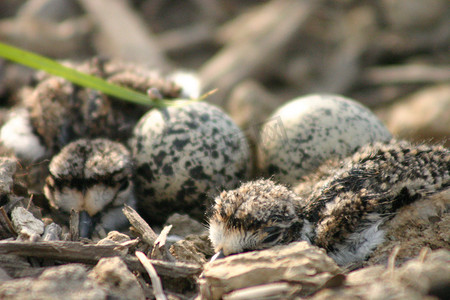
xmin=209 ymin=141 xmax=450 ymax=265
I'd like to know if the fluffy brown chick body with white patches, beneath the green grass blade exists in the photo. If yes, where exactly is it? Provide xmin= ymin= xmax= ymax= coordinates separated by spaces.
xmin=0 ymin=59 xmax=193 ymax=162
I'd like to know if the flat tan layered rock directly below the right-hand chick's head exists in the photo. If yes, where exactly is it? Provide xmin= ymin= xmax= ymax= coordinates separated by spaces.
xmin=200 ymin=242 xmax=340 ymax=299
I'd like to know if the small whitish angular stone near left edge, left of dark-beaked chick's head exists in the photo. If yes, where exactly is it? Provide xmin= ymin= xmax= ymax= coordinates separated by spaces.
xmin=11 ymin=206 xmax=44 ymax=239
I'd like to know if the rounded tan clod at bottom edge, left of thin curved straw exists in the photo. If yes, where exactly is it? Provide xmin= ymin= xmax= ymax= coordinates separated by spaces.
xmin=89 ymin=256 xmax=145 ymax=299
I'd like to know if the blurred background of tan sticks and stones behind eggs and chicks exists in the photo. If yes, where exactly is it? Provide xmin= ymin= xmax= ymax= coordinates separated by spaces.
xmin=0 ymin=0 xmax=450 ymax=146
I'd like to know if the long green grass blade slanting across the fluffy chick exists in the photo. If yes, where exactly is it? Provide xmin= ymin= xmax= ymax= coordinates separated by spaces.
xmin=0 ymin=42 xmax=175 ymax=107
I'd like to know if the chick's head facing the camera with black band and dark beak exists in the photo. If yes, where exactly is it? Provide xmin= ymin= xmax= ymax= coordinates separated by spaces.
xmin=44 ymin=139 xmax=135 ymax=237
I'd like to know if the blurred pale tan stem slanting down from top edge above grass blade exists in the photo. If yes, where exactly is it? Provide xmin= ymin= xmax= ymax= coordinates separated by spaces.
xmin=79 ymin=0 xmax=170 ymax=70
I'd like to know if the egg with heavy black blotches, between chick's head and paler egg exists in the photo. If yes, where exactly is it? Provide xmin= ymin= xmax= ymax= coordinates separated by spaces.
xmin=130 ymin=102 xmax=250 ymax=223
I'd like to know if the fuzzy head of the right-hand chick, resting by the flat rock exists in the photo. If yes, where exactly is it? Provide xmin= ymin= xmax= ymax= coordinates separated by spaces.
xmin=208 ymin=180 xmax=308 ymax=256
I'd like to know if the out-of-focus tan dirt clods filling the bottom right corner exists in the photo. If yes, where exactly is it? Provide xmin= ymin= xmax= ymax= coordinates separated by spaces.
xmin=312 ymin=249 xmax=450 ymax=299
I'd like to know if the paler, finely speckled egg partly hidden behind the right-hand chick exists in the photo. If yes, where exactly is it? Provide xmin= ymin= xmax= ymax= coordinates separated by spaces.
xmin=258 ymin=94 xmax=392 ymax=185
